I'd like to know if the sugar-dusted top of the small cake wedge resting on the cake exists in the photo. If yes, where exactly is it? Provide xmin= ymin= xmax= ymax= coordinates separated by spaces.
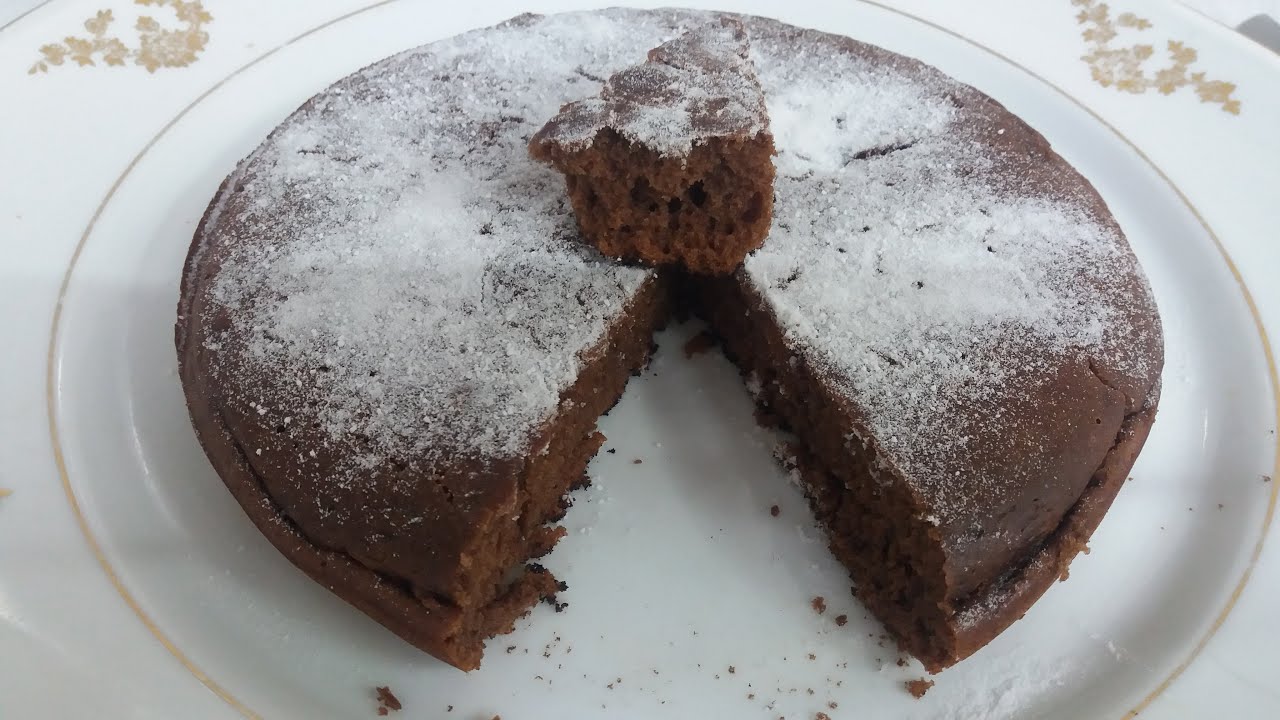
xmin=524 ymin=17 xmax=769 ymax=158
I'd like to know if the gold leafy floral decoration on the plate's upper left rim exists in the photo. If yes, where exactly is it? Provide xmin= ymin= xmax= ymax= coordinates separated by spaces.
xmin=27 ymin=0 xmax=214 ymax=74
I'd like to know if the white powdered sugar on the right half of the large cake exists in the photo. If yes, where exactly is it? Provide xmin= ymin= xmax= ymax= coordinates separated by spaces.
xmin=742 ymin=25 xmax=1151 ymax=524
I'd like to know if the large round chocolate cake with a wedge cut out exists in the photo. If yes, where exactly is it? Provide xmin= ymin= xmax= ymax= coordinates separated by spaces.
xmin=177 ymin=10 xmax=1162 ymax=671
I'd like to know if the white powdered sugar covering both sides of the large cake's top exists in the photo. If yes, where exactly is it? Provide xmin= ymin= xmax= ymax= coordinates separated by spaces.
xmin=186 ymin=10 xmax=1161 ymax=538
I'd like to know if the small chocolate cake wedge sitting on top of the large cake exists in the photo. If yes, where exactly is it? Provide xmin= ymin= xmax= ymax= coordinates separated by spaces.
xmin=529 ymin=18 xmax=773 ymax=274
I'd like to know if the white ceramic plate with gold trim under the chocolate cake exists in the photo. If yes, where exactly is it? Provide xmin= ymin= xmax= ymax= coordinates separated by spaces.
xmin=0 ymin=0 xmax=1280 ymax=720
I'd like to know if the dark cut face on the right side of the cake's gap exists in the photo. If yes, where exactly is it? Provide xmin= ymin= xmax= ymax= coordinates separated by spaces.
xmin=691 ymin=279 xmax=956 ymax=670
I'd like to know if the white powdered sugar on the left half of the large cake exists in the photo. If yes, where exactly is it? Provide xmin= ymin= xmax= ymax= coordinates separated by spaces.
xmin=204 ymin=13 xmax=711 ymax=470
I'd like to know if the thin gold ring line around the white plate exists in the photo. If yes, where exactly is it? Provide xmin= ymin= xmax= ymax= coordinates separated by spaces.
xmin=24 ymin=0 xmax=1280 ymax=720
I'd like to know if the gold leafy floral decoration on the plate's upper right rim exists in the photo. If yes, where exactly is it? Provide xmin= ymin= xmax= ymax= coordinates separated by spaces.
xmin=1071 ymin=0 xmax=1240 ymax=115
